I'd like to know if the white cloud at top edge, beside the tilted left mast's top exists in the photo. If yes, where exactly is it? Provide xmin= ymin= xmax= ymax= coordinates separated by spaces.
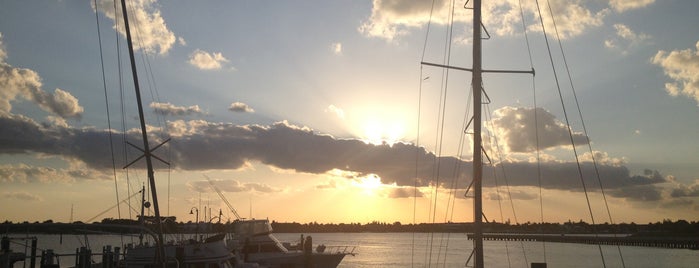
xmin=90 ymin=0 xmax=178 ymax=55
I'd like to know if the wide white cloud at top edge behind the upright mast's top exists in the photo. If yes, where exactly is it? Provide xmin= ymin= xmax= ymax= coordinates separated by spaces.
xmin=358 ymin=0 xmax=609 ymax=41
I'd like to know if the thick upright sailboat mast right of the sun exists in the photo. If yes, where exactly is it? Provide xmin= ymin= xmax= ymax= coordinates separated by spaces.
xmin=471 ymin=0 xmax=484 ymax=268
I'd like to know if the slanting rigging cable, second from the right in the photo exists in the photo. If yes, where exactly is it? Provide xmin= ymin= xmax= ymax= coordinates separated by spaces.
xmin=536 ymin=0 xmax=607 ymax=267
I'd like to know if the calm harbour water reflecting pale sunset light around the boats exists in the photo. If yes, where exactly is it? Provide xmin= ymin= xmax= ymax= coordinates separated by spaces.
xmin=2 ymin=233 xmax=699 ymax=268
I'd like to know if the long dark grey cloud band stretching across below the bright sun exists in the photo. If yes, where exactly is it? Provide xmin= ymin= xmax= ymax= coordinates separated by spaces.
xmin=0 ymin=116 xmax=694 ymax=206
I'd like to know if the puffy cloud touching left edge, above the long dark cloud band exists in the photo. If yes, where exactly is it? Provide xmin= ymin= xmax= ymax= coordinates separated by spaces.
xmin=0 ymin=34 xmax=84 ymax=119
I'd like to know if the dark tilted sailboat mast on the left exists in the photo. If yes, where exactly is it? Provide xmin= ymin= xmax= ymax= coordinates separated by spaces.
xmin=121 ymin=0 xmax=165 ymax=263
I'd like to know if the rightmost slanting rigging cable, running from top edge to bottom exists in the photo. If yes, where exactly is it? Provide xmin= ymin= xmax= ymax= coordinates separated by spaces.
xmin=546 ymin=0 xmax=626 ymax=267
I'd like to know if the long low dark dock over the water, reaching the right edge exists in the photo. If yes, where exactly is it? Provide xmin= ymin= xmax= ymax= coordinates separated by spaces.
xmin=467 ymin=233 xmax=699 ymax=250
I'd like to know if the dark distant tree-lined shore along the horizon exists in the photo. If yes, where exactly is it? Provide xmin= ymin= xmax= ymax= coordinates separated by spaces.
xmin=0 ymin=217 xmax=699 ymax=238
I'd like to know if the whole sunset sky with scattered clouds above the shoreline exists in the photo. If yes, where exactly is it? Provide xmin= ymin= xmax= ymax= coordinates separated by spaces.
xmin=0 ymin=0 xmax=699 ymax=226
